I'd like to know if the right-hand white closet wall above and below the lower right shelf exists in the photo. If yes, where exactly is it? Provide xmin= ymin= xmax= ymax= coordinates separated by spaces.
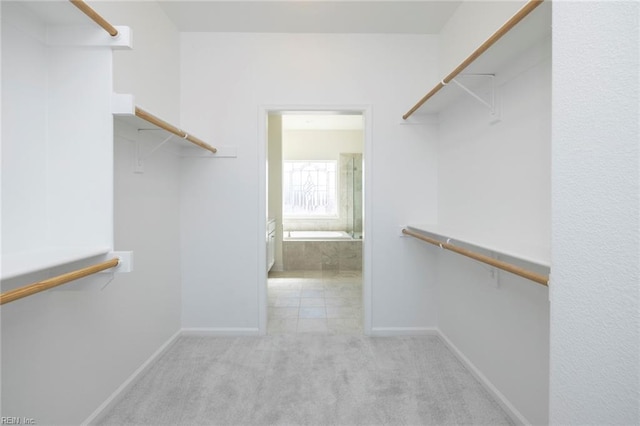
xmin=430 ymin=13 xmax=551 ymax=424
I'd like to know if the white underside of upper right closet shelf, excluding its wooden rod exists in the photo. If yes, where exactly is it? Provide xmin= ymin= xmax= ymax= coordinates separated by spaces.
xmin=408 ymin=0 xmax=552 ymax=116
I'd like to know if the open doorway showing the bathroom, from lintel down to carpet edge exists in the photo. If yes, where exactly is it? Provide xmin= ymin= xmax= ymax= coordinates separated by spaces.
xmin=266 ymin=111 xmax=365 ymax=334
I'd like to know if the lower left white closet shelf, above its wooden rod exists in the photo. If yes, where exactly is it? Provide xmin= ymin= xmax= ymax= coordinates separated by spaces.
xmin=0 ymin=247 xmax=111 ymax=280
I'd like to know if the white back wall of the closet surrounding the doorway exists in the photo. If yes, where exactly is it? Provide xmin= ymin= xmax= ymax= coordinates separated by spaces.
xmin=181 ymin=33 xmax=437 ymax=332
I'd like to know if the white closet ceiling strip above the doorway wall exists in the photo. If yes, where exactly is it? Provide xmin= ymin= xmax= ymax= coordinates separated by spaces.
xmin=159 ymin=0 xmax=461 ymax=34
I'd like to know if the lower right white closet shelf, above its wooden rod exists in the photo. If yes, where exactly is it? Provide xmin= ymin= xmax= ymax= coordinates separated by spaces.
xmin=407 ymin=224 xmax=551 ymax=268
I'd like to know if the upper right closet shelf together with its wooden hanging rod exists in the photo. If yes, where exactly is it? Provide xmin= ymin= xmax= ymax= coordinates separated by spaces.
xmin=403 ymin=0 xmax=551 ymax=120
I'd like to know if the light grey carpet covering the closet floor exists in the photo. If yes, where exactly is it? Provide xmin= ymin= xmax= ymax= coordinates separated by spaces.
xmin=98 ymin=334 xmax=512 ymax=425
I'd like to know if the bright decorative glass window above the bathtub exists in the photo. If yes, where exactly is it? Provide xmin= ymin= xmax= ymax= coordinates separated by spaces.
xmin=282 ymin=160 xmax=338 ymax=218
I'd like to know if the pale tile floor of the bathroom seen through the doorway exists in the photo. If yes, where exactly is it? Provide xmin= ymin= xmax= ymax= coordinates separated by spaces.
xmin=267 ymin=271 xmax=363 ymax=334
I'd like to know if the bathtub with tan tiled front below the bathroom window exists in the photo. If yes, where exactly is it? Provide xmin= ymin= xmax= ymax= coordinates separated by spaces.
xmin=282 ymin=231 xmax=362 ymax=271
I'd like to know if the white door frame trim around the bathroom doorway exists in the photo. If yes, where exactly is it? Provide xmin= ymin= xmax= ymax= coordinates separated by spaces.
xmin=256 ymin=105 xmax=373 ymax=335
